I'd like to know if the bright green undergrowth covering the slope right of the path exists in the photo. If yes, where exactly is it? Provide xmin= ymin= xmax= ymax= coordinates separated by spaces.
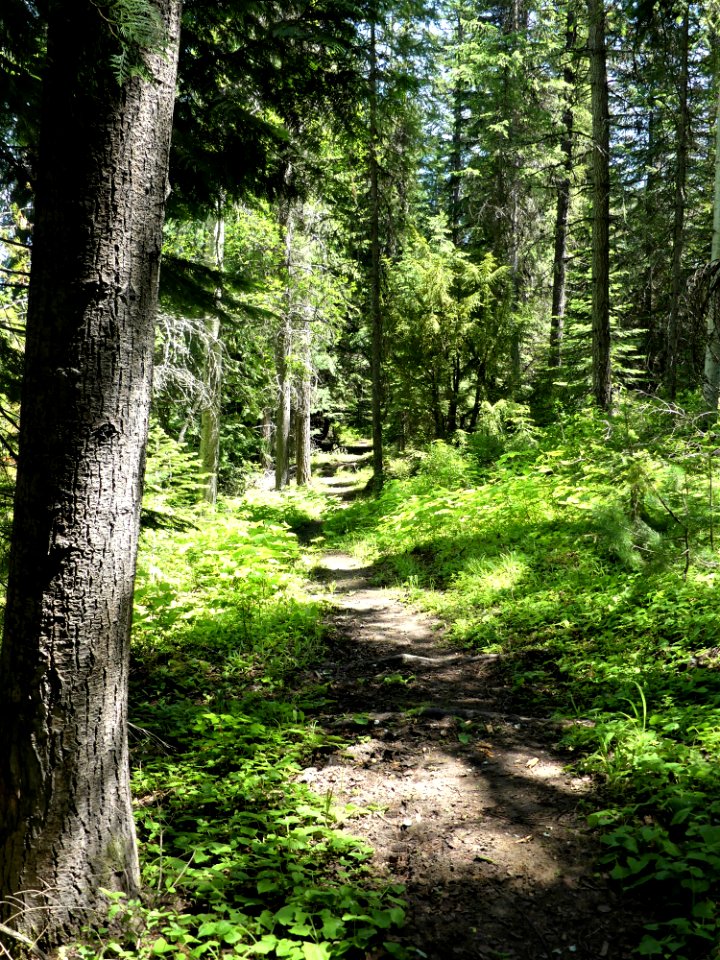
xmin=326 ymin=402 xmax=720 ymax=958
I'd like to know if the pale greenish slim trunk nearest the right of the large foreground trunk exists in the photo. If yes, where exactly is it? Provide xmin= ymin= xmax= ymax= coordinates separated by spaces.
xmin=200 ymin=206 xmax=225 ymax=506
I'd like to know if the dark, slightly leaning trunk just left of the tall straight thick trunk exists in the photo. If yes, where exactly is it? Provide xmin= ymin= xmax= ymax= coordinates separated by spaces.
xmin=550 ymin=0 xmax=577 ymax=368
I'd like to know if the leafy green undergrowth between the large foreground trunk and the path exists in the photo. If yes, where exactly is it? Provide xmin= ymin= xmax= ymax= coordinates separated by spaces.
xmin=74 ymin=486 xmax=408 ymax=960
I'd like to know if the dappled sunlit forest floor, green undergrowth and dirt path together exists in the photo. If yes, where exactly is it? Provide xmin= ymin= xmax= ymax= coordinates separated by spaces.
xmin=115 ymin=404 xmax=720 ymax=960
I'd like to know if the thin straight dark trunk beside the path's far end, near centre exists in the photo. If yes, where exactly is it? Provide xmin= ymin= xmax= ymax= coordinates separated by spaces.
xmin=368 ymin=21 xmax=385 ymax=493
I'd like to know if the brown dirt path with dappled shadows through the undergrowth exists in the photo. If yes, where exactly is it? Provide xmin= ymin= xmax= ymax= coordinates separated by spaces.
xmin=302 ymin=553 xmax=638 ymax=960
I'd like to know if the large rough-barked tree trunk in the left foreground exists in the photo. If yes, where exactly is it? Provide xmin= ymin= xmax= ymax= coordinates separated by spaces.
xmin=0 ymin=0 xmax=180 ymax=951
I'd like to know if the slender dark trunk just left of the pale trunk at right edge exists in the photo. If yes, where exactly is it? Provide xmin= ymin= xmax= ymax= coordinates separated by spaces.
xmin=667 ymin=4 xmax=690 ymax=400
